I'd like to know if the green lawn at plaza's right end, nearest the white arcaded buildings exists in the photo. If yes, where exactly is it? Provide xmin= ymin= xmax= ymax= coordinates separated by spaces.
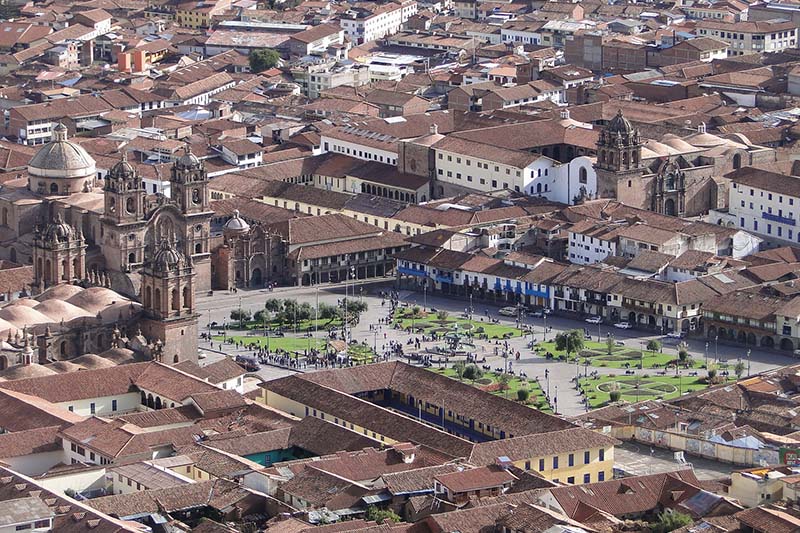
xmin=535 ymin=339 xmax=703 ymax=369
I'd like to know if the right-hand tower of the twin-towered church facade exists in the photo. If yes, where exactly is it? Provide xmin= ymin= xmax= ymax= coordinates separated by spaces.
xmin=170 ymin=144 xmax=214 ymax=291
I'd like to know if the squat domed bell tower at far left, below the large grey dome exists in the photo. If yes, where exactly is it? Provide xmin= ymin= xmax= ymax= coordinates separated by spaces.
xmin=33 ymin=213 xmax=86 ymax=292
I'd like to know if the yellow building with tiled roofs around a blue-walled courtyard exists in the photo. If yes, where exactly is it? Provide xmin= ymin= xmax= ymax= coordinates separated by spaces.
xmin=261 ymin=363 xmax=618 ymax=484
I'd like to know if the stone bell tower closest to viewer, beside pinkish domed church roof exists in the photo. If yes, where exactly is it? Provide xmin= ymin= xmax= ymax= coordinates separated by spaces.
xmin=141 ymin=239 xmax=198 ymax=364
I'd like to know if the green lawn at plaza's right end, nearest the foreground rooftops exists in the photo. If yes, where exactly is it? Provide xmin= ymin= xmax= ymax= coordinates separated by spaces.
xmin=580 ymin=374 xmax=708 ymax=408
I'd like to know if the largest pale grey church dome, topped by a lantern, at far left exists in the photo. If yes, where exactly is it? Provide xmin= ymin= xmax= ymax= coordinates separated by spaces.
xmin=28 ymin=124 xmax=96 ymax=179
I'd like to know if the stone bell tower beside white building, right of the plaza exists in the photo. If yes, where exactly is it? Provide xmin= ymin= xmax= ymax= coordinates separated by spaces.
xmin=595 ymin=109 xmax=644 ymax=202
